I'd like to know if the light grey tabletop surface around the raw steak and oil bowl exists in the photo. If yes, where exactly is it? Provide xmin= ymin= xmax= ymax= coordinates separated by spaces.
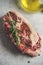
xmin=0 ymin=0 xmax=43 ymax=65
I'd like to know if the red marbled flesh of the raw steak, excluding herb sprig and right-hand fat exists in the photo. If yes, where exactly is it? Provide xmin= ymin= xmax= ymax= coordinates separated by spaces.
xmin=3 ymin=11 xmax=41 ymax=56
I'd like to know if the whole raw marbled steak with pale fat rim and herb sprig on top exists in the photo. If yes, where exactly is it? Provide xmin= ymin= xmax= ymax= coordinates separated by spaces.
xmin=3 ymin=11 xmax=41 ymax=56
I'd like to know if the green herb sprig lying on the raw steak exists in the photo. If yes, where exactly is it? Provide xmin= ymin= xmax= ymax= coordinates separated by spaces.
xmin=10 ymin=20 xmax=20 ymax=45
